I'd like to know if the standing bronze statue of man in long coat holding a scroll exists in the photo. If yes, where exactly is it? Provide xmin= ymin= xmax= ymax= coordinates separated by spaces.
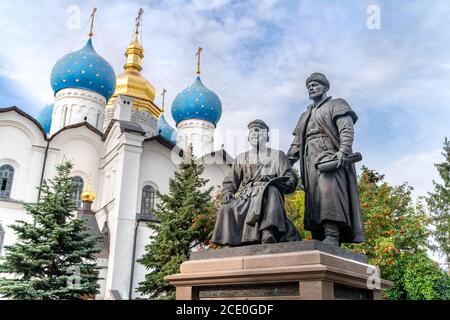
xmin=287 ymin=73 xmax=364 ymax=246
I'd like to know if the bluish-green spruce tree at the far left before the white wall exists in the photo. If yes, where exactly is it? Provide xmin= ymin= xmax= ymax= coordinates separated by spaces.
xmin=0 ymin=162 xmax=99 ymax=300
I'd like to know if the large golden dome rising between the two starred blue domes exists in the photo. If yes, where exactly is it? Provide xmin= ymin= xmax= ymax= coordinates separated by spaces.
xmin=107 ymin=32 xmax=161 ymax=118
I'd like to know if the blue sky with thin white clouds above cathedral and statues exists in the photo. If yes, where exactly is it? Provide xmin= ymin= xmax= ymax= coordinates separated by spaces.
xmin=0 ymin=0 xmax=450 ymax=195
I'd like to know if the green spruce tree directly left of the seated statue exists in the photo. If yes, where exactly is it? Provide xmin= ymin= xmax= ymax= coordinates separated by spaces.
xmin=137 ymin=147 xmax=215 ymax=299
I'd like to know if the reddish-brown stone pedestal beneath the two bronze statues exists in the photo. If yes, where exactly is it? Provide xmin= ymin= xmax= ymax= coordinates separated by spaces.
xmin=165 ymin=240 xmax=390 ymax=300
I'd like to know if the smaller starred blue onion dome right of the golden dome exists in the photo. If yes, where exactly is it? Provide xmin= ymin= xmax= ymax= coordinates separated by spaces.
xmin=172 ymin=76 xmax=222 ymax=125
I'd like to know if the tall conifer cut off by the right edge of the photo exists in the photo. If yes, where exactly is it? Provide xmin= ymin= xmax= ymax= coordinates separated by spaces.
xmin=427 ymin=138 xmax=450 ymax=267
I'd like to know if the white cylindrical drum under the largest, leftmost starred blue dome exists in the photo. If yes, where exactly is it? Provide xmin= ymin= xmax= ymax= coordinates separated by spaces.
xmin=50 ymin=89 xmax=106 ymax=135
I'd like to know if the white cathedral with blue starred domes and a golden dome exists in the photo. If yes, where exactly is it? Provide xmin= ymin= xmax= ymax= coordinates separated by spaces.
xmin=0 ymin=15 xmax=232 ymax=299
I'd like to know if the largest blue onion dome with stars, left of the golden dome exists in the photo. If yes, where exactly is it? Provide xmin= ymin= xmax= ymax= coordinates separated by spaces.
xmin=50 ymin=38 xmax=116 ymax=100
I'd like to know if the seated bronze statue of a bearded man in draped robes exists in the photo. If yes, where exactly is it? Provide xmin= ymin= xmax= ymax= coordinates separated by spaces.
xmin=211 ymin=120 xmax=301 ymax=246
